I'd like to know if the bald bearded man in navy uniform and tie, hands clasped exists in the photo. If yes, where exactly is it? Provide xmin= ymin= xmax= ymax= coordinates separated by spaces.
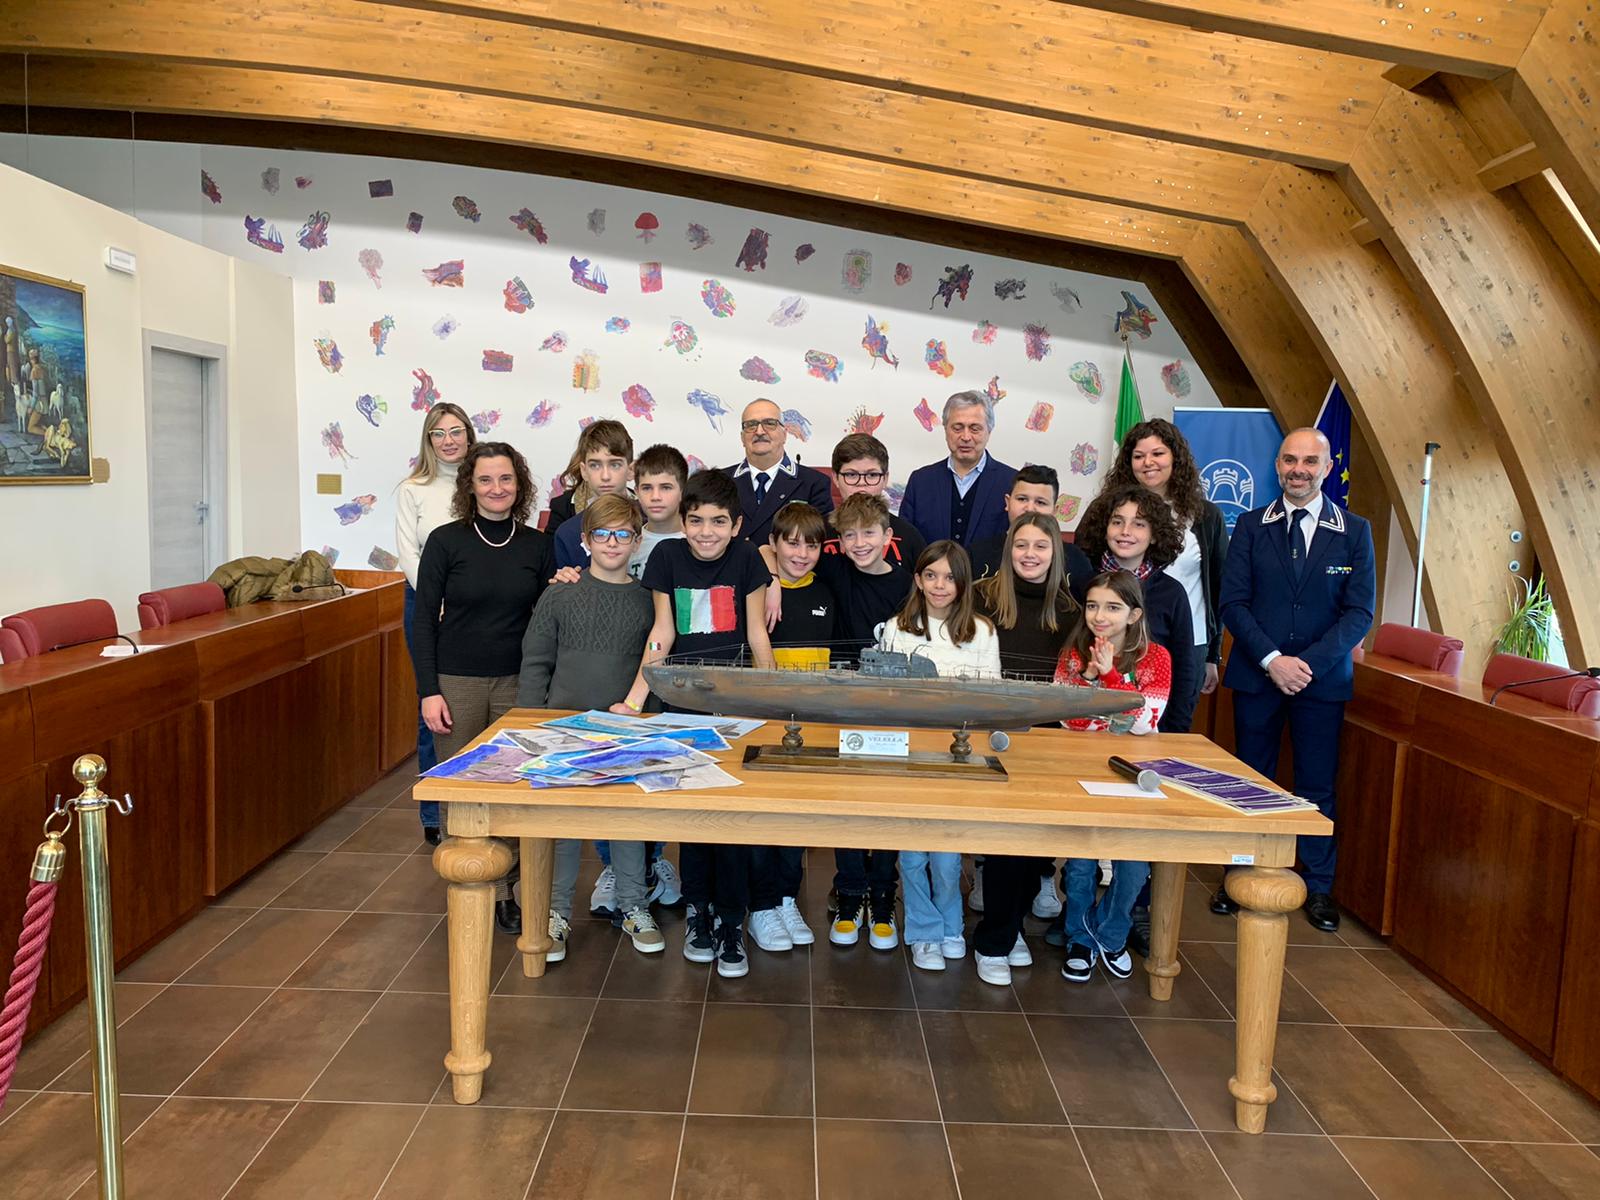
xmin=1211 ymin=429 xmax=1378 ymax=933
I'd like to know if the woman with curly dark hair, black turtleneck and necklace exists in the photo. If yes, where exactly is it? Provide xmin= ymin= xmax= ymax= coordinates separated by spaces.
xmin=411 ymin=442 xmax=555 ymax=933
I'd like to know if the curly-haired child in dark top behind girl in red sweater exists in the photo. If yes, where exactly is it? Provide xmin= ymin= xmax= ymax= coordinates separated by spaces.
xmin=1077 ymin=483 xmax=1198 ymax=733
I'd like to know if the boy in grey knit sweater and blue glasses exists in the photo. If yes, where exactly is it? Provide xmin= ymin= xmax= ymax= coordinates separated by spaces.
xmin=517 ymin=494 xmax=666 ymax=963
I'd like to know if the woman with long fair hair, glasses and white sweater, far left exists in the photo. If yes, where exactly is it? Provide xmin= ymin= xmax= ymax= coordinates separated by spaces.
xmin=395 ymin=403 xmax=478 ymax=845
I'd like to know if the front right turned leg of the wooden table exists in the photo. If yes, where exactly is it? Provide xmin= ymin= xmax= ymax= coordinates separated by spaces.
xmin=1227 ymin=867 xmax=1306 ymax=1133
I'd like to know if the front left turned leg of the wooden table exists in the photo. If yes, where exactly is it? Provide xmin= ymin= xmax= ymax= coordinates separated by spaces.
xmin=434 ymin=837 xmax=510 ymax=1104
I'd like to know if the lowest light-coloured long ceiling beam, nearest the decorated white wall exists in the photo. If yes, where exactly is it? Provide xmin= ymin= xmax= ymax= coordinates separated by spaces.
xmin=0 ymin=58 xmax=1195 ymax=258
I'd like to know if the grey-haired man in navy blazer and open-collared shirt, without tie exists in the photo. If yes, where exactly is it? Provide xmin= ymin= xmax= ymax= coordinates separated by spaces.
xmin=899 ymin=392 xmax=1016 ymax=547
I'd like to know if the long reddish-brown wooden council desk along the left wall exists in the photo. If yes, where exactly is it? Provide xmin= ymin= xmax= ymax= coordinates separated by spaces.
xmin=0 ymin=576 xmax=416 ymax=1029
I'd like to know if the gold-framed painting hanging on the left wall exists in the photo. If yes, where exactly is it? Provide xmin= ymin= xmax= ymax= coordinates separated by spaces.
xmin=0 ymin=266 xmax=90 ymax=485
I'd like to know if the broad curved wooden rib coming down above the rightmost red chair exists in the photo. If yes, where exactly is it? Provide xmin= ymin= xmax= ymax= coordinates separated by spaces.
xmin=1347 ymin=93 xmax=1600 ymax=662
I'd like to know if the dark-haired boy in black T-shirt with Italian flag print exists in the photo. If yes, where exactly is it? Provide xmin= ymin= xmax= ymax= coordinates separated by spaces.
xmin=611 ymin=470 xmax=776 ymax=978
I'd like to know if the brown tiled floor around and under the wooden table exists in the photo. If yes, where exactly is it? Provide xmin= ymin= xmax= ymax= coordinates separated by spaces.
xmin=0 ymin=773 xmax=1600 ymax=1200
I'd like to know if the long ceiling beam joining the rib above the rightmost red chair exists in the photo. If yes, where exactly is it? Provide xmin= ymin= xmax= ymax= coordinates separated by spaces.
xmin=380 ymin=0 xmax=1389 ymax=168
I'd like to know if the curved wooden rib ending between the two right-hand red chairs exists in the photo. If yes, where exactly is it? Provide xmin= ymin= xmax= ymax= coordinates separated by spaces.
xmin=1245 ymin=166 xmax=1522 ymax=670
